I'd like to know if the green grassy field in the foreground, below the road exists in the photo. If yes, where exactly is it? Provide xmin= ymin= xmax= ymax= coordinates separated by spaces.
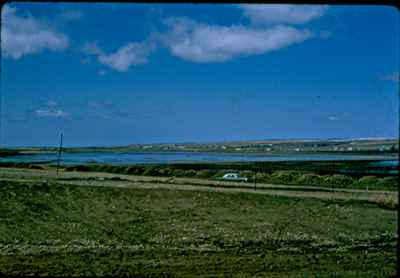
xmin=0 ymin=168 xmax=397 ymax=277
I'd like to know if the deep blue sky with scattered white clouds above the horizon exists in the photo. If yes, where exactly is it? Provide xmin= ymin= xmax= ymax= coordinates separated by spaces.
xmin=0 ymin=3 xmax=399 ymax=146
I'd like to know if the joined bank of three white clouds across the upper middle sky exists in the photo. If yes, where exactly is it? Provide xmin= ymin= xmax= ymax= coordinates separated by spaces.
xmin=77 ymin=4 xmax=327 ymax=70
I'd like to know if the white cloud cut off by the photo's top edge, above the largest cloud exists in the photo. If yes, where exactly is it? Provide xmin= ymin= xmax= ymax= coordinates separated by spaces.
xmin=240 ymin=4 xmax=328 ymax=24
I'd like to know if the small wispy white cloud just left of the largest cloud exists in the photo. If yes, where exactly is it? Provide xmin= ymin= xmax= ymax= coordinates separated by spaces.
xmin=82 ymin=41 xmax=154 ymax=72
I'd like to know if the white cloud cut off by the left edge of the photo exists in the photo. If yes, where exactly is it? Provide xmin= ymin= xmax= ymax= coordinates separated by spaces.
xmin=1 ymin=5 xmax=69 ymax=60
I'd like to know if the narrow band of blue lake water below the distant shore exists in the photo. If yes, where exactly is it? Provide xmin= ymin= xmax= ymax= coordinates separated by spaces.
xmin=0 ymin=152 xmax=398 ymax=165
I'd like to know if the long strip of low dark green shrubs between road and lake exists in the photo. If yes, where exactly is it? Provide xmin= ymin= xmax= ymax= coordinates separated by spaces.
xmin=0 ymin=161 xmax=399 ymax=191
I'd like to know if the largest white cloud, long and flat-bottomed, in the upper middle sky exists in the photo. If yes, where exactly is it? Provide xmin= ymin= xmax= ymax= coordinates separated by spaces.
xmin=161 ymin=18 xmax=312 ymax=63
